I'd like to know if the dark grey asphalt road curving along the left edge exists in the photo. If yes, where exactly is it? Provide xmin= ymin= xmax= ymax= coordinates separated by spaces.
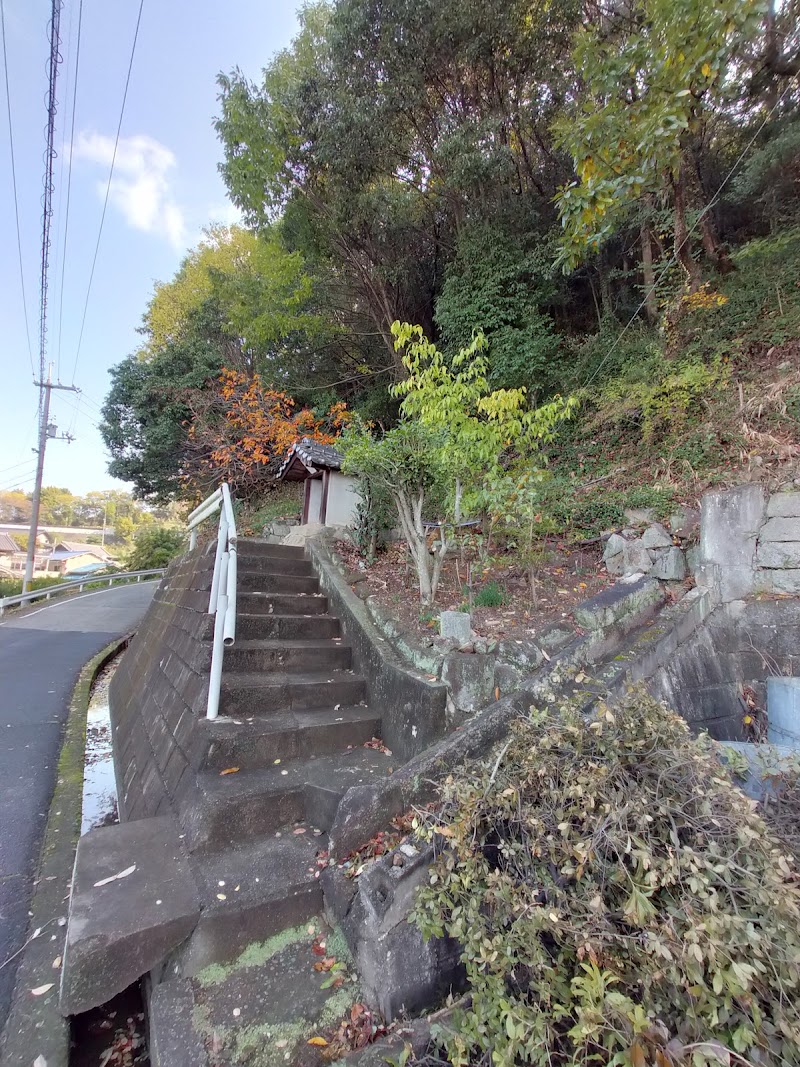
xmin=0 ymin=582 xmax=157 ymax=1032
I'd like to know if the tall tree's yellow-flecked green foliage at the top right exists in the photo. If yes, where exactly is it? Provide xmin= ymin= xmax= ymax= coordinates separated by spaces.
xmin=557 ymin=0 xmax=763 ymax=286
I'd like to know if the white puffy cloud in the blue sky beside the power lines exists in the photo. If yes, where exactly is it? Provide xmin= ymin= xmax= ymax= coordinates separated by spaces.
xmin=75 ymin=132 xmax=186 ymax=250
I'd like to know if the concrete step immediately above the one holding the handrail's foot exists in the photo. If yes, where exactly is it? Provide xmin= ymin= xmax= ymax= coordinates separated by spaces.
xmin=220 ymin=668 xmax=367 ymax=719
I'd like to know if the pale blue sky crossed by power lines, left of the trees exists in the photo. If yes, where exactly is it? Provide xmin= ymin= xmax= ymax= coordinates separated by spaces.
xmin=0 ymin=0 xmax=297 ymax=493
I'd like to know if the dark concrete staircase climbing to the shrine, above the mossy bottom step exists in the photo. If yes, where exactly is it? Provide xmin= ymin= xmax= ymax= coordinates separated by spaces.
xmin=179 ymin=540 xmax=391 ymax=974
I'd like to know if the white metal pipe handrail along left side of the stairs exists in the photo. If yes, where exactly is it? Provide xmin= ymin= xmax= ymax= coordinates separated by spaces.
xmin=188 ymin=483 xmax=236 ymax=719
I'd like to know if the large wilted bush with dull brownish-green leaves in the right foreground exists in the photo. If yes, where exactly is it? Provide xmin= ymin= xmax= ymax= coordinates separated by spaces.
xmin=414 ymin=690 xmax=800 ymax=1067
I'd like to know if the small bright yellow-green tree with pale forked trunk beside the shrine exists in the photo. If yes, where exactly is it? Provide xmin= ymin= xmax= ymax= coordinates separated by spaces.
xmin=340 ymin=322 xmax=576 ymax=604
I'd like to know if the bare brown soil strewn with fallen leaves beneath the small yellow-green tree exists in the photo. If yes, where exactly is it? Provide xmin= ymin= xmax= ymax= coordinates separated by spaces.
xmin=336 ymin=541 xmax=612 ymax=639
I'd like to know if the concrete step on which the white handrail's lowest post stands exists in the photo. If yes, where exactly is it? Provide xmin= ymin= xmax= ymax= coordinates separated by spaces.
xmin=201 ymin=704 xmax=381 ymax=773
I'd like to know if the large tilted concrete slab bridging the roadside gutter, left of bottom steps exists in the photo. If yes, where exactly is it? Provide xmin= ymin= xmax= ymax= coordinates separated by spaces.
xmin=61 ymin=816 xmax=199 ymax=1015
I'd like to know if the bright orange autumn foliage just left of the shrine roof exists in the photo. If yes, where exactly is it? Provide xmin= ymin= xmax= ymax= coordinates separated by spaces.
xmin=189 ymin=368 xmax=350 ymax=497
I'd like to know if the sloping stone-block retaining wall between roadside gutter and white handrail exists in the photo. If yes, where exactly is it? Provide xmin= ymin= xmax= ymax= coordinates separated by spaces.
xmin=109 ymin=544 xmax=214 ymax=822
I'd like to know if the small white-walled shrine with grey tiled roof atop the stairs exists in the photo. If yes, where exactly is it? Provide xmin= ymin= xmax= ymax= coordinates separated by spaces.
xmin=276 ymin=437 xmax=358 ymax=526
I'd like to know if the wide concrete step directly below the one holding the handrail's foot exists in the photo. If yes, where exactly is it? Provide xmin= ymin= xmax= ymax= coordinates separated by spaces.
xmin=186 ymin=747 xmax=393 ymax=853
